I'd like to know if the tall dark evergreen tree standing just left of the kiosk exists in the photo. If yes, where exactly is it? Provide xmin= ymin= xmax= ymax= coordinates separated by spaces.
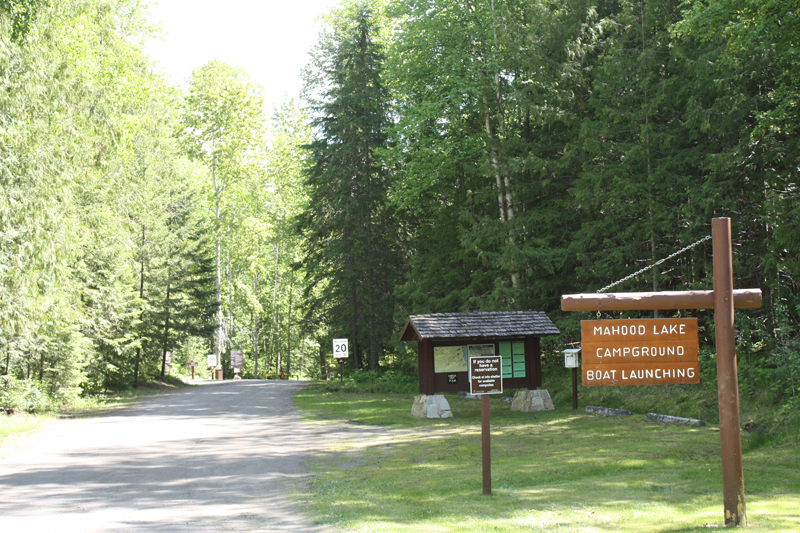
xmin=298 ymin=4 xmax=397 ymax=369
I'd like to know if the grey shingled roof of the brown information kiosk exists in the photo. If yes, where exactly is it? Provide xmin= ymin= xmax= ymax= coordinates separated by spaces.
xmin=400 ymin=311 xmax=560 ymax=341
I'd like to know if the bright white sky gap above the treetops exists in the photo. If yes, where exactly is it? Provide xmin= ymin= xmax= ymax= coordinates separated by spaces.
xmin=147 ymin=0 xmax=338 ymax=114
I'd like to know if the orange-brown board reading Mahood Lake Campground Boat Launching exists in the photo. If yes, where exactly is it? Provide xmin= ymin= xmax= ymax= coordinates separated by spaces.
xmin=581 ymin=318 xmax=700 ymax=386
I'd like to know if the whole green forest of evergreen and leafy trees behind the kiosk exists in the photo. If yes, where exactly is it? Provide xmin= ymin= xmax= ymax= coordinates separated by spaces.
xmin=0 ymin=0 xmax=800 ymax=409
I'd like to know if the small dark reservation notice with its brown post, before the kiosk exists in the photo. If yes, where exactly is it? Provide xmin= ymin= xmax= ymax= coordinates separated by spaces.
xmin=469 ymin=355 xmax=503 ymax=496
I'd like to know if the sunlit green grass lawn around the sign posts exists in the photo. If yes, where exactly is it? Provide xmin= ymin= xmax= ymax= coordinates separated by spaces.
xmin=295 ymin=389 xmax=800 ymax=533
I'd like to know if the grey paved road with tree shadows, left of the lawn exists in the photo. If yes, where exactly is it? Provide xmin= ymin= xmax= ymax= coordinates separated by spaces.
xmin=0 ymin=381 xmax=346 ymax=533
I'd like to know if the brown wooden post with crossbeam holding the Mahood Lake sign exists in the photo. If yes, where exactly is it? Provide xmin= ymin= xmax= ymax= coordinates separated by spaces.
xmin=561 ymin=218 xmax=761 ymax=526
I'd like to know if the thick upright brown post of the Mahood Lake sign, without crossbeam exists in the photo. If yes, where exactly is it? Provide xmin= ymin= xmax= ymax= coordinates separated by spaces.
xmin=711 ymin=218 xmax=747 ymax=526
